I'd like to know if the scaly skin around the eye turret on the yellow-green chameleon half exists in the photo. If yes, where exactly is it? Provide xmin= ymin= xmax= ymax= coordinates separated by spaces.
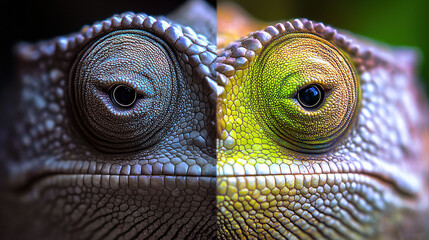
xmin=216 ymin=19 xmax=427 ymax=239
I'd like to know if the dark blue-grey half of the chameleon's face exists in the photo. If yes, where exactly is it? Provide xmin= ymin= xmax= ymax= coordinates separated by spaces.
xmin=0 ymin=1 xmax=216 ymax=239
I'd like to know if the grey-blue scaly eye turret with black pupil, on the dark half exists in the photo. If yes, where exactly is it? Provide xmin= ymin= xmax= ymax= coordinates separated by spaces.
xmin=69 ymin=30 xmax=183 ymax=153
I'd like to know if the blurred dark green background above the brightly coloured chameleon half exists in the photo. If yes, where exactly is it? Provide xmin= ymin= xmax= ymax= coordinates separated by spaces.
xmin=218 ymin=0 xmax=429 ymax=93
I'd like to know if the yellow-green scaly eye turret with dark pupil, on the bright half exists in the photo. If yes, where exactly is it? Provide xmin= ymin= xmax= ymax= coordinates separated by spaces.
xmin=249 ymin=33 xmax=359 ymax=153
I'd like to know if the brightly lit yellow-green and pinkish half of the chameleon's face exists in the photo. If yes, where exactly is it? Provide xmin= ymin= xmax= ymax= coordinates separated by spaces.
xmin=216 ymin=5 xmax=429 ymax=239
